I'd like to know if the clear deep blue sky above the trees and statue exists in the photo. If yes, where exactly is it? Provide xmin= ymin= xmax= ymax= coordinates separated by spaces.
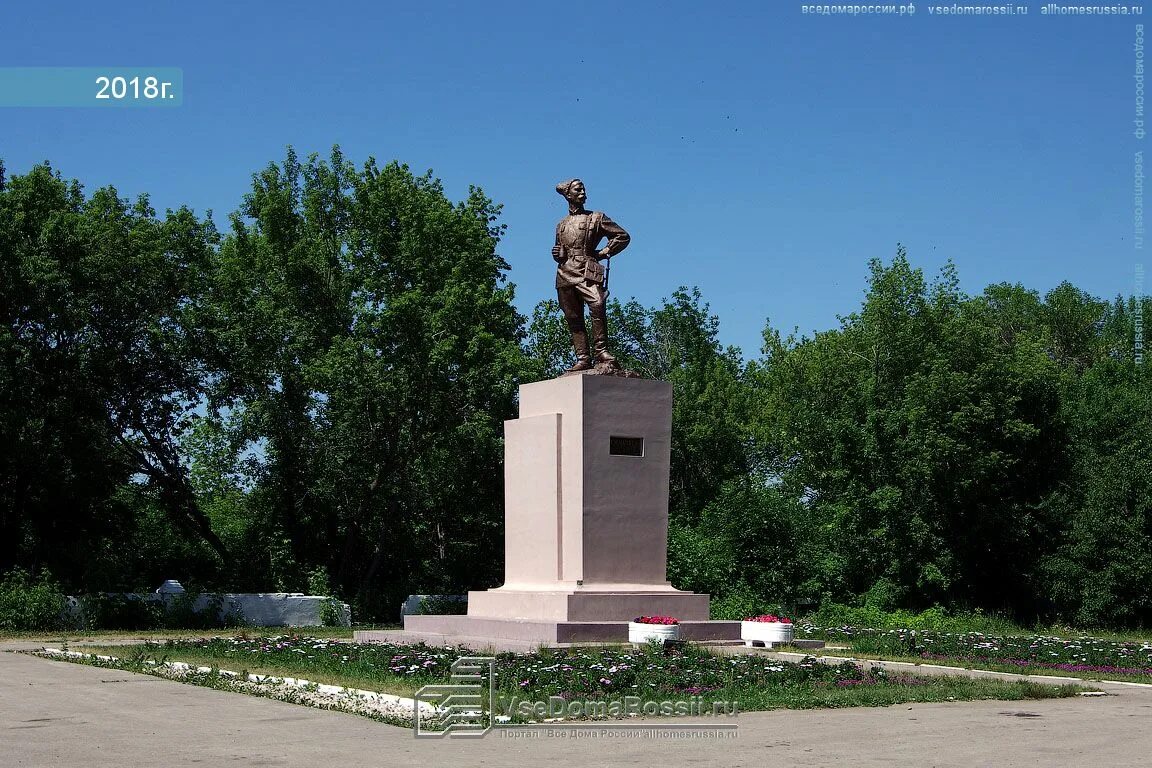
xmin=0 ymin=0 xmax=1152 ymax=355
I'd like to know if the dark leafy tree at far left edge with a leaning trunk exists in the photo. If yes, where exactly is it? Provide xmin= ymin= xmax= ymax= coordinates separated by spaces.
xmin=0 ymin=158 xmax=227 ymax=580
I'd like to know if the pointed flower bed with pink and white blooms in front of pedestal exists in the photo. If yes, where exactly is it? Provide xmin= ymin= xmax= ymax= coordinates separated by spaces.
xmin=49 ymin=625 xmax=1077 ymax=721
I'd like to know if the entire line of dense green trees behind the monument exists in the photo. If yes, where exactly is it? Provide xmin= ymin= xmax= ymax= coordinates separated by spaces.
xmin=0 ymin=150 xmax=1152 ymax=626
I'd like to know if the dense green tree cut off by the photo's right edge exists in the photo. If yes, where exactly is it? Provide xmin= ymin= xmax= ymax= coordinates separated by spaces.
xmin=1044 ymin=291 xmax=1152 ymax=626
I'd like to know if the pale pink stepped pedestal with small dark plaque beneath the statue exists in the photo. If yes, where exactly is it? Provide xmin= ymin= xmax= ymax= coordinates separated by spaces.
xmin=382 ymin=375 xmax=718 ymax=642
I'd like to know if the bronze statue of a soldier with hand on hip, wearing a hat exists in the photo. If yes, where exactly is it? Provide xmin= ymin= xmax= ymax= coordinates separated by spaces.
xmin=552 ymin=178 xmax=630 ymax=373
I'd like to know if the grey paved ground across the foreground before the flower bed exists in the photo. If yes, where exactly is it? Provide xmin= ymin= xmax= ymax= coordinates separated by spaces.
xmin=0 ymin=642 xmax=1152 ymax=768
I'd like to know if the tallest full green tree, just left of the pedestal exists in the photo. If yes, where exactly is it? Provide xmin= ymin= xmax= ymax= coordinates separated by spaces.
xmin=205 ymin=149 xmax=523 ymax=615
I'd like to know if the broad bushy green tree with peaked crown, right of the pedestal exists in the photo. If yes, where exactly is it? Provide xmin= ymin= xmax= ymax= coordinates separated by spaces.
xmin=760 ymin=249 xmax=1066 ymax=610
